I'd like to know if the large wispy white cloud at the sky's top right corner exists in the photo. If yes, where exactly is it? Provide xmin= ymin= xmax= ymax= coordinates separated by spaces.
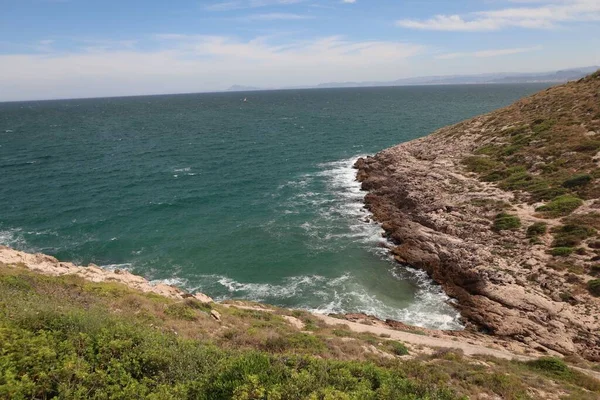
xmin=396 ymin=0 xmax=600 ymax=32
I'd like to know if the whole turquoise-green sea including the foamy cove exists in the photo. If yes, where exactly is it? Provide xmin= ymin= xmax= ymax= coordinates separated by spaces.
xmin=0 ymin=85 xmax=544 ymax=328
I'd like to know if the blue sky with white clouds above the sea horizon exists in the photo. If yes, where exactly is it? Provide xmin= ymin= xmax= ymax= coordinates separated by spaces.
xmin=0 ymin=0 xmax=600 ymax=101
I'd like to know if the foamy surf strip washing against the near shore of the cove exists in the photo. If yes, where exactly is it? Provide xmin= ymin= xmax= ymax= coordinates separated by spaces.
xmin=171 ymin=271 xmax=463 ymax=330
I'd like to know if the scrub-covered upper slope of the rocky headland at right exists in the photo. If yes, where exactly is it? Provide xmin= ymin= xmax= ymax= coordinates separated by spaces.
xmin=463 ymin=71 xmax=600 ymax=294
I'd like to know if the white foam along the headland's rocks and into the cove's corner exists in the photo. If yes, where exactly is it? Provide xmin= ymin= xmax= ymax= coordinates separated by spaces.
xmin=270 ymin=156 xmax=462 ymax=329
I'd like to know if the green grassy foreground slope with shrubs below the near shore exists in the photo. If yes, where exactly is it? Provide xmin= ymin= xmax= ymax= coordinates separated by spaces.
xmin=0 ymin=265 xmax=600 ymax=399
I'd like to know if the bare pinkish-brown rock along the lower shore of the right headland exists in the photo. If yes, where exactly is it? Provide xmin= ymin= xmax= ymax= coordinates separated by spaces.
xmin=355 ymin=100 xmax=600 ymax=361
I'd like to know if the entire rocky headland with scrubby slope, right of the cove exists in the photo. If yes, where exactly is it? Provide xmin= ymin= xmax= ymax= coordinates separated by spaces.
xmin=356 ymin=74 xmax=600 ymax=361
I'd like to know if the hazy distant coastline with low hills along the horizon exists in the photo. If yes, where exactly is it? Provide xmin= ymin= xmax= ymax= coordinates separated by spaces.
xmin=227 ymin=66 xmax=600 ymax=92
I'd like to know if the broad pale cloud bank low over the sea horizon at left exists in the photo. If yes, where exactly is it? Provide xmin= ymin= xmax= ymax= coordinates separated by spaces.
xmin=0 ymin=33 xmax=424 ymax=101
